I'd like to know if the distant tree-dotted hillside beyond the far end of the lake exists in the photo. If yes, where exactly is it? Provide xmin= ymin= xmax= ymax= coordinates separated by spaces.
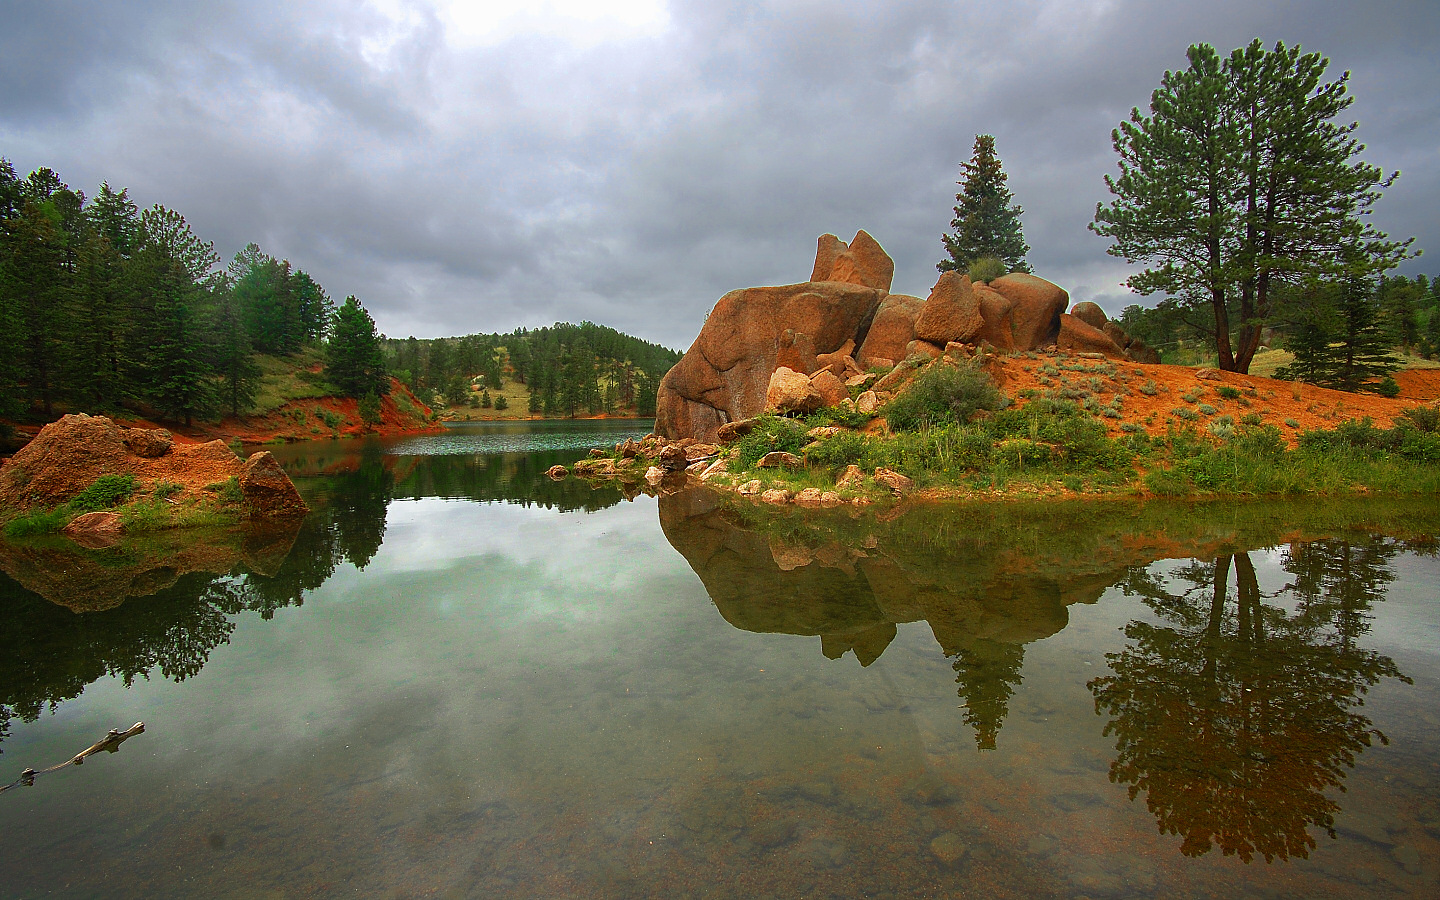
xmin=384 ymin=323 xmax=680 ymax=419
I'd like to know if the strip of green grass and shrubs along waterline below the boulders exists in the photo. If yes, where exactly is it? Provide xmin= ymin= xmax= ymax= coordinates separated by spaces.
xmin=590 ymin=355 xmax=1440 ymax=500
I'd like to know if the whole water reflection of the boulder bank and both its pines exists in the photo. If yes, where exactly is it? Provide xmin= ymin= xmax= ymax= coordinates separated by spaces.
xmin=660 ymin=492 xmax=1428 ymax=861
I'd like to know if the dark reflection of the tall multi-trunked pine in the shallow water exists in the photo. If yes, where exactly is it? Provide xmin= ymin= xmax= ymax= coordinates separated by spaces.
xmin=1089 ymin=539 xmax=1408 ymax=861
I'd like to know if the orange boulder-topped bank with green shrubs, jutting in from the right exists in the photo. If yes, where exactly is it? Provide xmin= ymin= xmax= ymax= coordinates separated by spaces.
xmin=550 ymin=230 xmax=1440 ymax=507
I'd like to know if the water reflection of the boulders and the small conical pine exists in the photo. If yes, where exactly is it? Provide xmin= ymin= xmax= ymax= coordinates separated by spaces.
xmin=660 ymin=491 xmax=1125 ymax=750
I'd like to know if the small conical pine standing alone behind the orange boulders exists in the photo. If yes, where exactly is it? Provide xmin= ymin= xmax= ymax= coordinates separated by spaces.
xmin=935 ymin=134 xmax=1030 ymax=272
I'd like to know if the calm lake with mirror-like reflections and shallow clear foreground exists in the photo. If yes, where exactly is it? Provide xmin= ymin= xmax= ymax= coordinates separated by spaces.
xmin=0 ymin=420 xmax=1440 ymax=899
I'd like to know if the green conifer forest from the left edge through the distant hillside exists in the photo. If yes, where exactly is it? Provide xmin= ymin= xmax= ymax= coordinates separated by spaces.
xmin=0 ymin=158 xmax=678 ymax=425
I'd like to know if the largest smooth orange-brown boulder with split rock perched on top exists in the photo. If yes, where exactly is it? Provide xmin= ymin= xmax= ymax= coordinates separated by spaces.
xmin=655 ymin=232 xmax=894 ymax=442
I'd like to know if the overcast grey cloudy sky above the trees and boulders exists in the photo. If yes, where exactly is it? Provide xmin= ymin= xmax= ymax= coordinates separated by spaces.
xmin=0 ymin=0 xmax=1440 ymax=348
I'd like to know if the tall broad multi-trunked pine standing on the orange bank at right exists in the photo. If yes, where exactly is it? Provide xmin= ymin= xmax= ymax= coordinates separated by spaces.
xmin=1092 ymin=40 xmax=1410 ymax=372
